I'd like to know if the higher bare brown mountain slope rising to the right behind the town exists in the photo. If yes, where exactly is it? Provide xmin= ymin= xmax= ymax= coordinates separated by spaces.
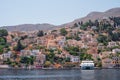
xmin=64 ymin=8 xmax=120 ymax=26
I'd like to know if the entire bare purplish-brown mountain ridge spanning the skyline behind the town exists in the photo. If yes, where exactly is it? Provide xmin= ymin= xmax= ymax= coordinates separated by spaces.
xmin=0 ymin=8 xmax=120 ymax=31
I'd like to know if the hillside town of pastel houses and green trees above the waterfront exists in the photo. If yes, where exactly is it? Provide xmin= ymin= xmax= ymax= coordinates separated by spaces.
xmin=0 ymin=17 xmax=120 ymax=69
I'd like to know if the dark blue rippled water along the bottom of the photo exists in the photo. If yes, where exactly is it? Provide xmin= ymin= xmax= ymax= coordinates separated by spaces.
xmin=0 ymin=69 xmax=120 ymax=80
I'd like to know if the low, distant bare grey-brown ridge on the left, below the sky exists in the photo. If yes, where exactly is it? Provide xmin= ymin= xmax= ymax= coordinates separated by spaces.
xmin=0 ymin=24 xmax=56 ymax=31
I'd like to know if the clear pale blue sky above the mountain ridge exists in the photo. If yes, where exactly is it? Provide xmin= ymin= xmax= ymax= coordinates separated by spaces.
xmin=0 ymin=0 xmax=120 ymax=26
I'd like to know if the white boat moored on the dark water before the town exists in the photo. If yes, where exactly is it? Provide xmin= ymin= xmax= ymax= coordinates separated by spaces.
xmin=80 ymin=60 xmax=94 ymax=70
